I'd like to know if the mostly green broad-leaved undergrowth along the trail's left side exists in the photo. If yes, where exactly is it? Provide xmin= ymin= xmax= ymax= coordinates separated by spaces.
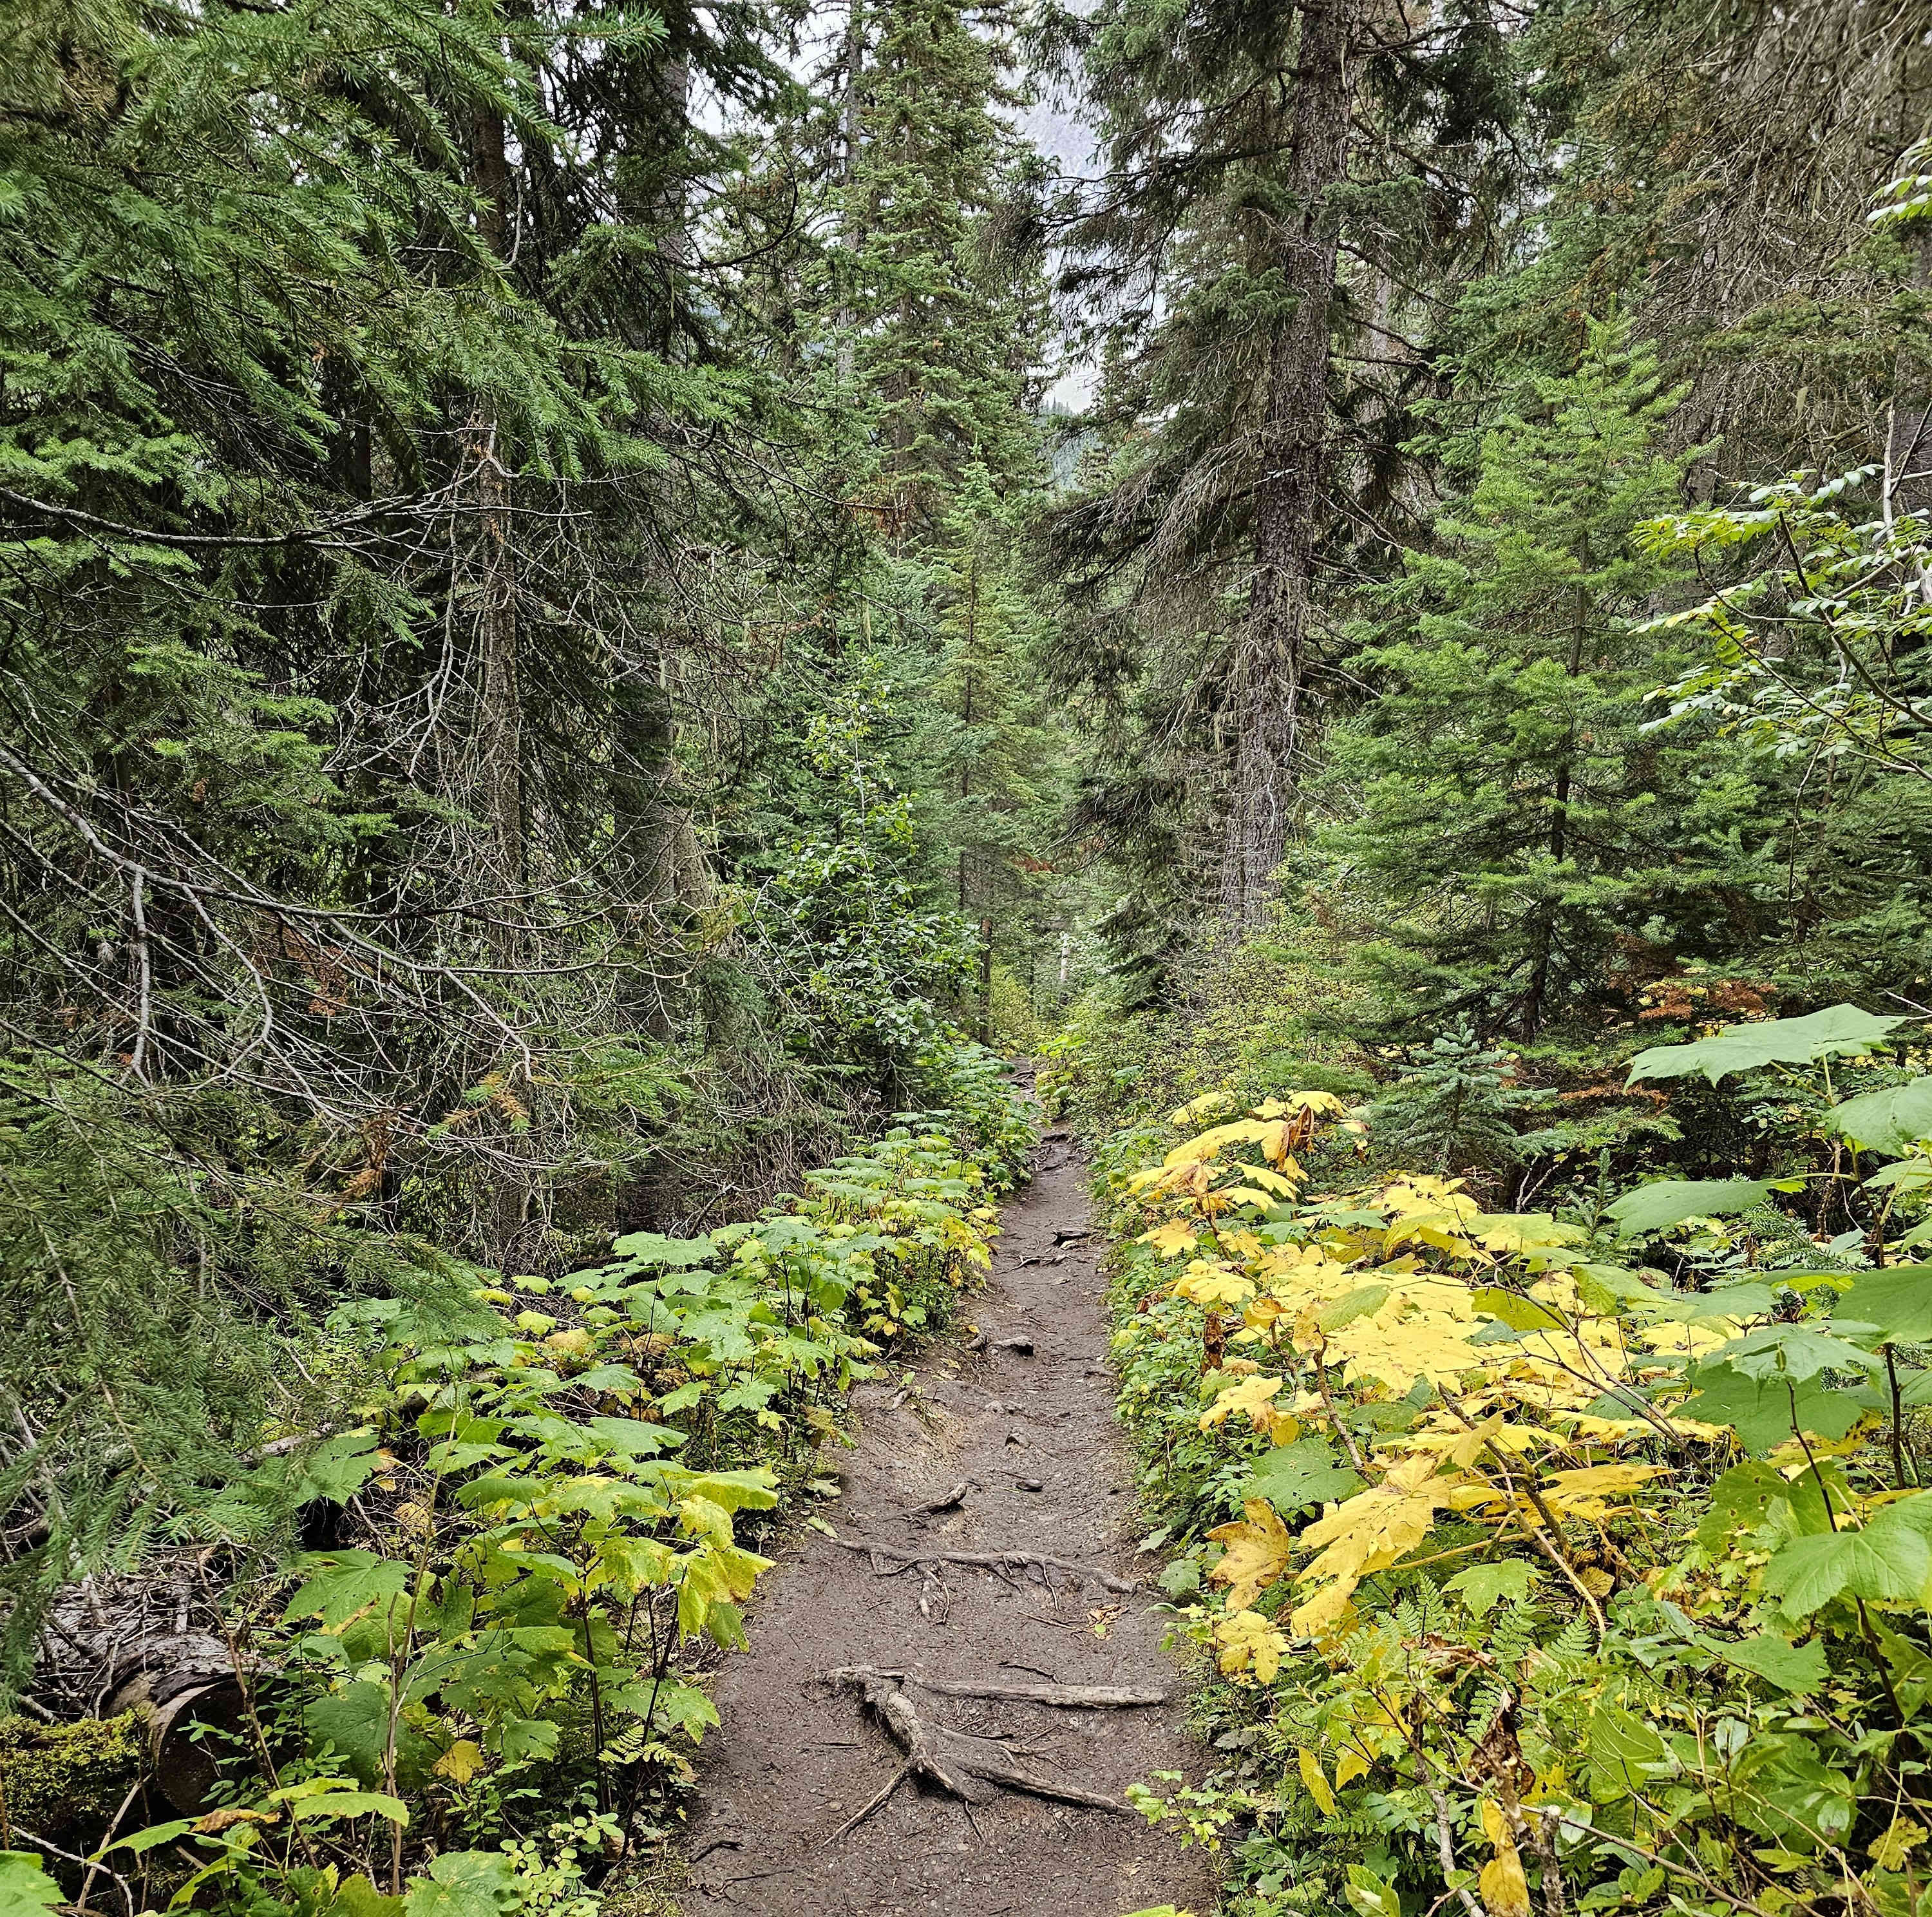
xmin=0 ymin=1049 xmax=1034 ymax=1917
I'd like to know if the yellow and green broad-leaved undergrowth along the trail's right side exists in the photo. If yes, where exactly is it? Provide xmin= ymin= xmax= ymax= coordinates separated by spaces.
xmin=1043 ymin=1005 xmax=1932 ymax=1917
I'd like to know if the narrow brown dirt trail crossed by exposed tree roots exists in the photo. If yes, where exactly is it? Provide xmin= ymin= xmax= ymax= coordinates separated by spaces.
xmin=684 ymin=1136 xmax=1213 ymax=1917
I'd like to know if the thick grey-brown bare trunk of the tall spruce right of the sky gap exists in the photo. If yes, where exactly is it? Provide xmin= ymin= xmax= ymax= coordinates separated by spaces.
xmin=1221 ymin=0 xmax=1349 ymax=937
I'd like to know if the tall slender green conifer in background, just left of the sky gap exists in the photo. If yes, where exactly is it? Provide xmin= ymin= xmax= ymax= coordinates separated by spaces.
xmin=723 ymin=0 xmax=1045 ymax=1022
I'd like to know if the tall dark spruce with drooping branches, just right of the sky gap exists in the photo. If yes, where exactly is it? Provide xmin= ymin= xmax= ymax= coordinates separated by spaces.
xmin=1053 ymin=0 xmax=1509 ymax=933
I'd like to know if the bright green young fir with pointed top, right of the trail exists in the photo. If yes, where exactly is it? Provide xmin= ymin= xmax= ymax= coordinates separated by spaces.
xmin=1325 ymin=325 xmax=1776 ymax=1034
